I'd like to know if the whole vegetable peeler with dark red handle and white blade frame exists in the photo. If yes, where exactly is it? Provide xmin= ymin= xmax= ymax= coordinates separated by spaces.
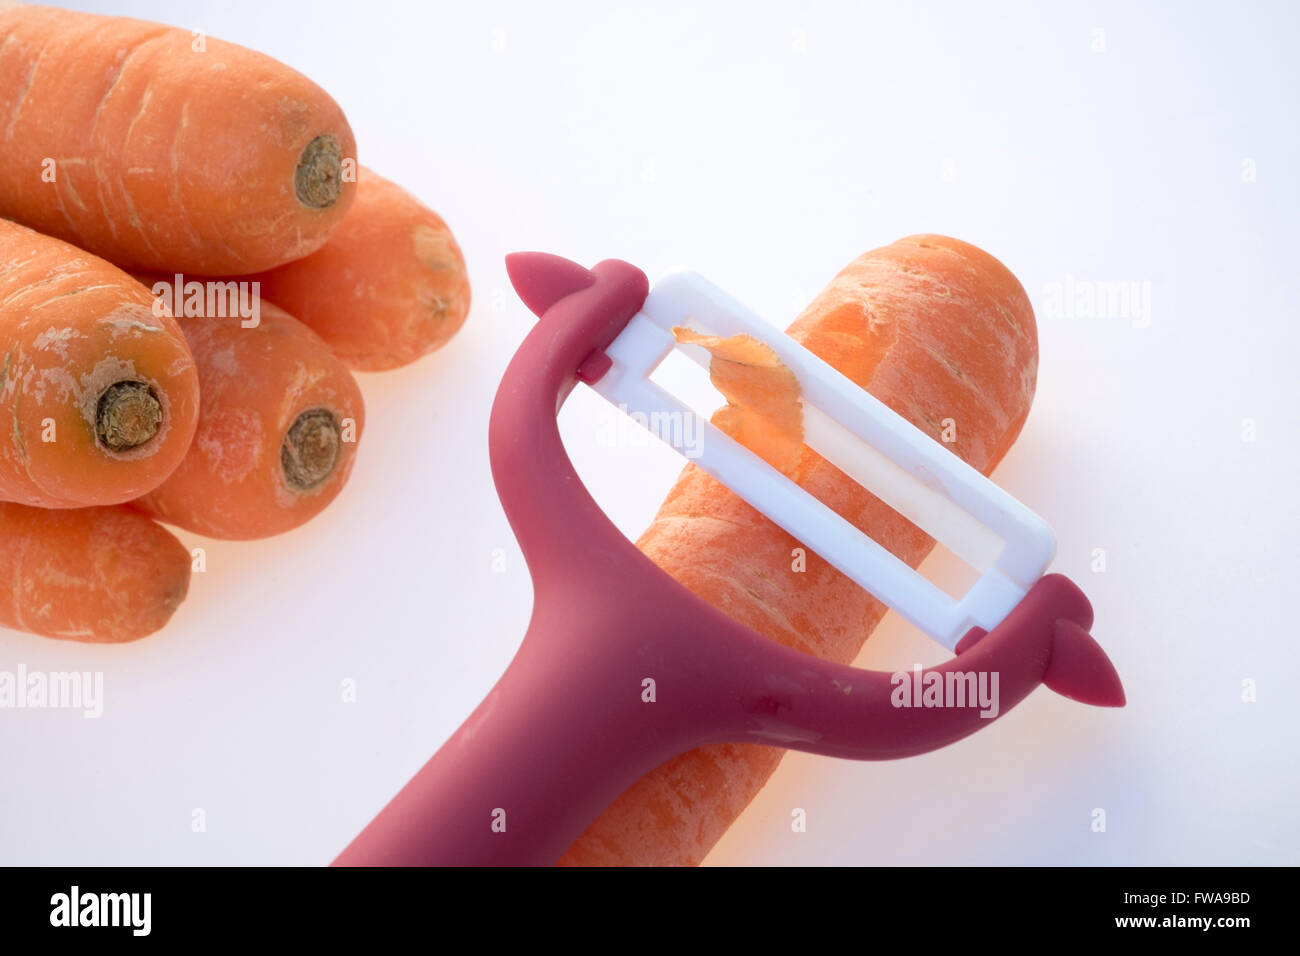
xmin=335 ymin=252 xmax=1125 ymax=866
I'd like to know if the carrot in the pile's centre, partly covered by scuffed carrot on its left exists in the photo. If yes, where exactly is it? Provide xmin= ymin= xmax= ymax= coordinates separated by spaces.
xmin=135 ymin=293 xmax=364 ymax=538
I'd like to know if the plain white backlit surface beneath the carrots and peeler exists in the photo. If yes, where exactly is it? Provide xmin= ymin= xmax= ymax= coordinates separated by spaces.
xmin=0 ymin=0 xmax=1300 ymax=864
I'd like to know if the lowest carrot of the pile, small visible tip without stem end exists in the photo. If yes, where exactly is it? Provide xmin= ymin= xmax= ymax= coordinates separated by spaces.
xmin=0 ymin=503 xmax=190 ymax=643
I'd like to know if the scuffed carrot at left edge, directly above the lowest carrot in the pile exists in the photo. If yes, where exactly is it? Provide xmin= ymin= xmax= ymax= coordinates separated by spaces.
xmin=0 ymin=220 xmax=199 ymax=507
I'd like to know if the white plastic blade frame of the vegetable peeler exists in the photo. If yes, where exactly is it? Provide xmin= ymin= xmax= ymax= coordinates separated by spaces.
xmin=593 ymin=272 xmax=1056 ymax=649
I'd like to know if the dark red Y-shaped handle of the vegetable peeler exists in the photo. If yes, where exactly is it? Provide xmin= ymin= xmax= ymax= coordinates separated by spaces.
xmin=335 ymin=252 xmax=1123 ymax=866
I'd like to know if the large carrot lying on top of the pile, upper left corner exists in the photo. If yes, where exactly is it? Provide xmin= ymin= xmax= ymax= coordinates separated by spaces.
xmin=0 ymin=4 xmax=356 ymax=273
